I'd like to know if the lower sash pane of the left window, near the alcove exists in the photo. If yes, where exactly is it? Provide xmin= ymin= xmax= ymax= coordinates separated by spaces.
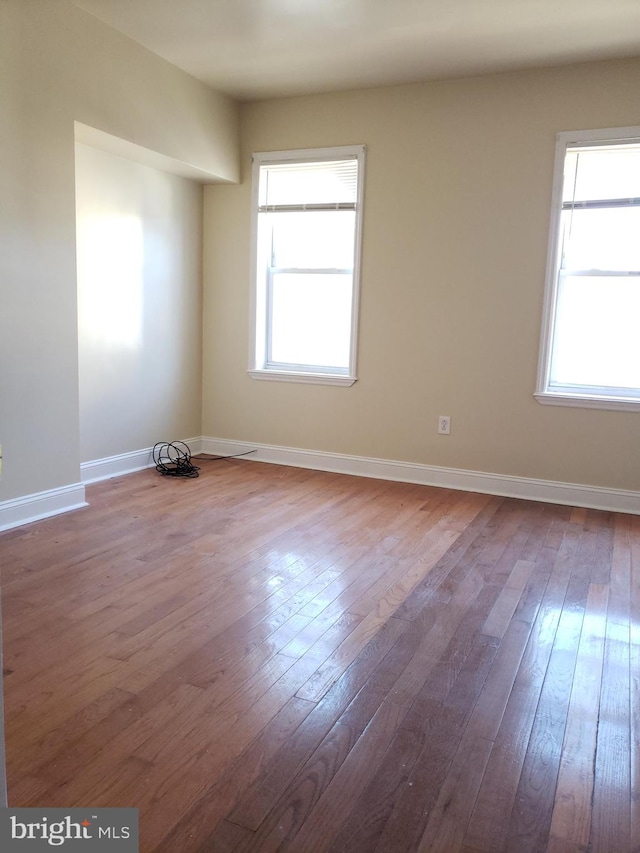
xmin=271 ymin=273 xmax=352 ymax=369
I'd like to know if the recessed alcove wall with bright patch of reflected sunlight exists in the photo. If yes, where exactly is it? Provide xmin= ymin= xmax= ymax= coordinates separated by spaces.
xmin=76 ymin=144 xmax=202 ymax=462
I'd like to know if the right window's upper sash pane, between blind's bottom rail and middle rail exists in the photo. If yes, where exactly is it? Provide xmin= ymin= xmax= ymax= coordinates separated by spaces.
xmin=562 ymin=207 xmax=640 ymax=271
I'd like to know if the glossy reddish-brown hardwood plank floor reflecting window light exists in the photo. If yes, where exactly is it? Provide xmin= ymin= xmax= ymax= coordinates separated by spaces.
xmin=0 ymin=460 xmax=640 ymax=853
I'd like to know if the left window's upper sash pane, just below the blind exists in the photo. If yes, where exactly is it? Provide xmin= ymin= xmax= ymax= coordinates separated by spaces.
xmin=263 ymin=210 xmax=356 ymax=270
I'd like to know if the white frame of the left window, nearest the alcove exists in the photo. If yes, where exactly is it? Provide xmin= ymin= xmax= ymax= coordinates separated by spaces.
xmin=248 ymin=145 xmax=365 ymax=386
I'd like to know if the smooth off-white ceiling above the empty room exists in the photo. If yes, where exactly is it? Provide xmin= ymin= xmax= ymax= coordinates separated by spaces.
xmin=74 ymin=0 xmax=640 ymax=100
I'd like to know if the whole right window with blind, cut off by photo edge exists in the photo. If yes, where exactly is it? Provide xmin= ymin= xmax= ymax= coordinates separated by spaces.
xmin=536 ymin=128 xmax=640 ymax=409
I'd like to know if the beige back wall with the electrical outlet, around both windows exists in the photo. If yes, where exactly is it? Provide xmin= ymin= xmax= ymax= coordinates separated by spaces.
xmin=203 ymin=60 xmax=640 ymax=490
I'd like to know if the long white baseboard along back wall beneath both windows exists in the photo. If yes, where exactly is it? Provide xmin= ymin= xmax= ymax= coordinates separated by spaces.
xmin=200 ymin=438 xmax=640 ymax=515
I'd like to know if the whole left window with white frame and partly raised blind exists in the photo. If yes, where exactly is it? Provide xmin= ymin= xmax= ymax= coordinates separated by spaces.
xmin=249 ymin=146 xmax=364 ymax=385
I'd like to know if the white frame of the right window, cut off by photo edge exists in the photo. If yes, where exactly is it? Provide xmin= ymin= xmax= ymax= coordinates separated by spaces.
xmin=534 ymin=127 xmax=640 ymax=411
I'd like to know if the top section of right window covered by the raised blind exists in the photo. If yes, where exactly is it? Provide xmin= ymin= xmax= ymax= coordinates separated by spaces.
xmin=562 ymin=144 xmax=640 ymax=201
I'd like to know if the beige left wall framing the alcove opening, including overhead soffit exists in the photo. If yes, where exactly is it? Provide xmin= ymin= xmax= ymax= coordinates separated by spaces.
xmin=0 ymin=0 xmax=237 ymax=503
